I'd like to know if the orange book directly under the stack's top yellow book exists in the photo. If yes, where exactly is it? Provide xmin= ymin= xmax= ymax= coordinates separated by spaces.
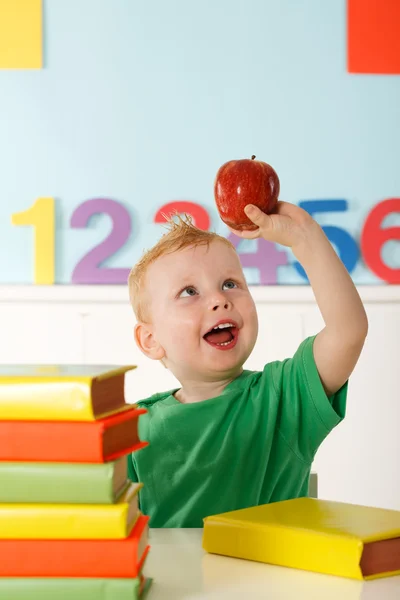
xmin=0 ymin=407 xmax=147 ymax=463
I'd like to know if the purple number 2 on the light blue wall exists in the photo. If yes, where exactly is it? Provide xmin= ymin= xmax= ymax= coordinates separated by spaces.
xmin=71 ymin=198 xmax=132 ymax=284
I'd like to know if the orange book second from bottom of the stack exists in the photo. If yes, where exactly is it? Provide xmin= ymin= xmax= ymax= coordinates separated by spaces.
xmin=0 ymin=515 xmax=149 ymax=578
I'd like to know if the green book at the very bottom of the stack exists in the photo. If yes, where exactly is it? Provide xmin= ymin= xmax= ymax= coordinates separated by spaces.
xmin=0 ymin=577 xmax=152 ymax=600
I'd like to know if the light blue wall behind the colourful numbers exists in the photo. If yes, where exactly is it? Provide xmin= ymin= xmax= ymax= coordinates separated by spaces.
xmin=0 ymin=0 xmax=400 ymax=283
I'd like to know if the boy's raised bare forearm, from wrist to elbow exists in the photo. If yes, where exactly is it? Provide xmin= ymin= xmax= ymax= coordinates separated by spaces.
xmin=293 ymin=223 xmax=368 ymax=340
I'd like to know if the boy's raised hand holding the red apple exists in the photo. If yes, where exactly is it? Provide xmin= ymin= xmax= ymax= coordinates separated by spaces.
xmin=230 ymin=202 xmax=318 ymax=248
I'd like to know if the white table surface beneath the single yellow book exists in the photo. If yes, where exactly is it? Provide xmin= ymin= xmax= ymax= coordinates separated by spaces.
xmin=144 ymin=529 xmax=400 ymax=600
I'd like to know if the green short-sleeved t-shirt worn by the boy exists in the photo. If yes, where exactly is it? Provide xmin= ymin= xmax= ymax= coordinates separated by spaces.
xmin=128 ymin=337 xmax=347 ymax=527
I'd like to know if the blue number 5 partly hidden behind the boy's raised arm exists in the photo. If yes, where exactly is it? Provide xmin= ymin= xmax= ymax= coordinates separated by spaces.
xmin=293 ymin=200 xmax=360 ymax=280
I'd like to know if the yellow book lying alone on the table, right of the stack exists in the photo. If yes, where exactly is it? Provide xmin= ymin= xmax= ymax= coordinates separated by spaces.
xmin=203 ymin=498 xmax=400 ymax=579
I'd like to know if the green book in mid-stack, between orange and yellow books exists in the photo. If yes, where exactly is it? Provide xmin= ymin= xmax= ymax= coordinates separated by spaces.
xmin=0 ymin=456 xmax=128 ymax=504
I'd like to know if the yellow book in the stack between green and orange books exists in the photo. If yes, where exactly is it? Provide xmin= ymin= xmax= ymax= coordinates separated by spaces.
xmin=0 ymin=483 xmax=142 ymax=540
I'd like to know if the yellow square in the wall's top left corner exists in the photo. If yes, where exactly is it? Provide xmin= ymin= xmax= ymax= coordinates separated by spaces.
xmin=0 ymin=0 xmax=42 ymax=69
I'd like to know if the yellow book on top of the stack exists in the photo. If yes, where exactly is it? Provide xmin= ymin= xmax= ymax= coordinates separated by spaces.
xmin=0 ymin=365 xmax=135 ymax=421
